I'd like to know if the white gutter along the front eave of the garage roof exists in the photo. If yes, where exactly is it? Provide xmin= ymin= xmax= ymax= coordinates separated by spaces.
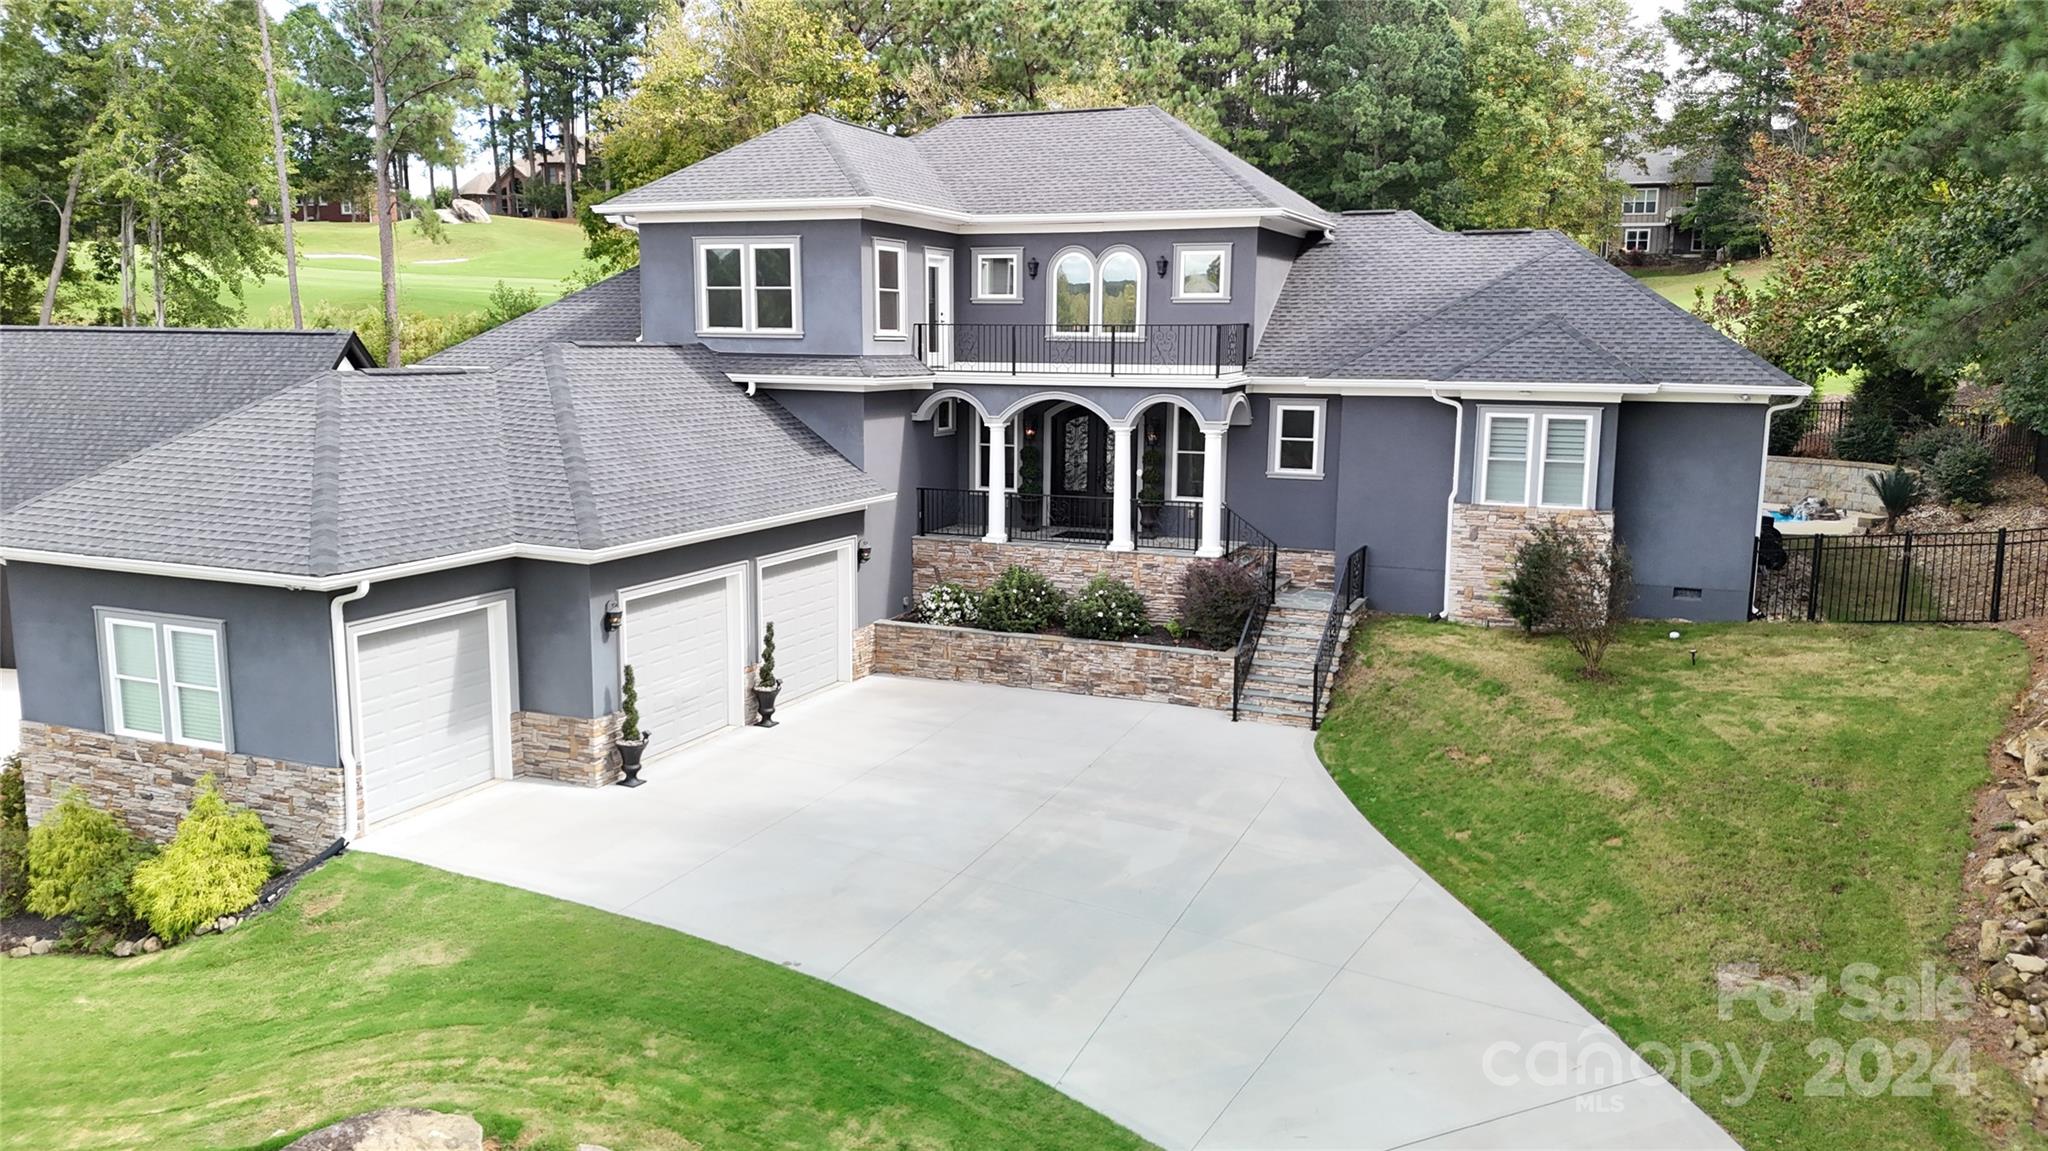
xmin=0 ymin=492 xmax=895 ymax=592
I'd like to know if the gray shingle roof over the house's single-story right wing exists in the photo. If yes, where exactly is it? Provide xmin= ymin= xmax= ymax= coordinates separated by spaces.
xmin=1251 ymin=211 xmax=1804 ymax=391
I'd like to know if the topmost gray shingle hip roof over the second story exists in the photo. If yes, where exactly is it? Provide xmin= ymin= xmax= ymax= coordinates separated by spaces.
xmin=598 ymin=104 xmax=1327 ymax=221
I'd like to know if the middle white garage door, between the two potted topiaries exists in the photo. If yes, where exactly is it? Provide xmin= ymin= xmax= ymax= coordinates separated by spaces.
xmin=625 ymin=578 xmax=743 ymax=752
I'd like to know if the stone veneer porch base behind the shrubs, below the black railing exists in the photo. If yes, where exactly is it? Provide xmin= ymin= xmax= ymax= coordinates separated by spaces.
xmin=917 ymin=537 xmax=1202 ymax=618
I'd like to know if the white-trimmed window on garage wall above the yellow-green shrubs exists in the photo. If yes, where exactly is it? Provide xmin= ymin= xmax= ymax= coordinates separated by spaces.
xmin=96 ymin=608 xmax=229 ymax=752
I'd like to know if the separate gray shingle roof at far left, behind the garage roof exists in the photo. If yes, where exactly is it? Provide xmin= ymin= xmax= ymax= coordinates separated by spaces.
xmin=0 ymin=326 xmax=371 ymax=508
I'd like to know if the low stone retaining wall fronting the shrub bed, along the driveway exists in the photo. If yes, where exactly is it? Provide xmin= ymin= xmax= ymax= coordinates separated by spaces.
xmin=872 ymin=621 xmax=1231 ymax=711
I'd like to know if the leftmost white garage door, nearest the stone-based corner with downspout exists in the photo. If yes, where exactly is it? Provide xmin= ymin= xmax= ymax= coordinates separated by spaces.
xmin=356 ymin=608 xmax=510 ymax=821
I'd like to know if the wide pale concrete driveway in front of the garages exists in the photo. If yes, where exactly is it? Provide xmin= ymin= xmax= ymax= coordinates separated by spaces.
xmin=356 ymin=678 xmax=1735 ymax=1149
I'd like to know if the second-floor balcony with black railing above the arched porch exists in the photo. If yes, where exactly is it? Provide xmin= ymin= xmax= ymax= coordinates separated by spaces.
xmin=915 ymin=324 xmax=1251 ymax=377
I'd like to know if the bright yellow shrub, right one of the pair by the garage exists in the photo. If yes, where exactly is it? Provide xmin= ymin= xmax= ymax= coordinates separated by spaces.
xmin=129 ymin=774 xmax=272 ymax=942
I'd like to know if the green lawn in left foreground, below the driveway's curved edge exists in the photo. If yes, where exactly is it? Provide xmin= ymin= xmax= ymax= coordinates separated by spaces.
xmin=0 ymin=854 xmax=1145 ymax=1151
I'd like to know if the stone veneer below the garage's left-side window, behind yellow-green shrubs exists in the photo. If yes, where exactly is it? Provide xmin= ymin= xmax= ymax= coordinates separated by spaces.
xmin=20 ymin=721 xmax=342 ymax=866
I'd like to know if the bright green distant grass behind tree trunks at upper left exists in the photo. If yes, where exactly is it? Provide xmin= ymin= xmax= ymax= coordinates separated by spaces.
xmin=244 ymin=217 xmax=584 ymax=326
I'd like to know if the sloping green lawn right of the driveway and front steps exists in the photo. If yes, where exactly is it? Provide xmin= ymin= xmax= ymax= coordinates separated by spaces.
xmin=1319 ymin=621 xmax=2042 ymax=1151
